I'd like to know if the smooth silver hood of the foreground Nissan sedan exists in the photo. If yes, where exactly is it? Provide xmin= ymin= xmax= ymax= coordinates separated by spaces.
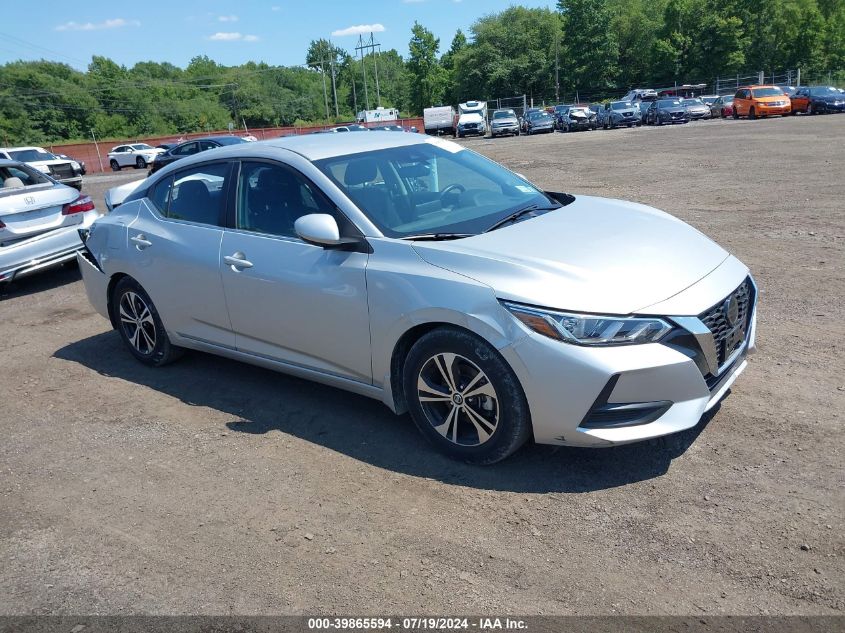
xmin=414 ymin=196 xmax=728 ymax=314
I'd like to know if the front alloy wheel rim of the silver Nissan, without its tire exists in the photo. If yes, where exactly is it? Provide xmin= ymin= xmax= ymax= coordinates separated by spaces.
xmin=417 ymin=352 xmax=499 ymax=446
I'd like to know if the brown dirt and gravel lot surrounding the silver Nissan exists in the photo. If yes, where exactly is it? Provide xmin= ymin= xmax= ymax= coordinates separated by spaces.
xmin=0 ymin=116 xmax=845 ymax=615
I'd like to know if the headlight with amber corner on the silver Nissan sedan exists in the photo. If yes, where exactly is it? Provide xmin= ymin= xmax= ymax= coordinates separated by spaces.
xmin=502 ymin=301 xmax=672 ymax=346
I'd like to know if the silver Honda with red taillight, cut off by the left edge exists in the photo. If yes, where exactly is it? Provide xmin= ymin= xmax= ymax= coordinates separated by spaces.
xmin=0 ymin=159 xmax=98 ymax=282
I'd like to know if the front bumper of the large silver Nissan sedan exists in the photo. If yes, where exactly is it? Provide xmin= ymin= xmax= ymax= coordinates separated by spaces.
xmin=500 ymin=264 xmax=756 ymax=447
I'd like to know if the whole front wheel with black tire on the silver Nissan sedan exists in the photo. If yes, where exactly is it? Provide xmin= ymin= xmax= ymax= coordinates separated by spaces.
xmin=403 ymin=328 xmax=531 ymax=465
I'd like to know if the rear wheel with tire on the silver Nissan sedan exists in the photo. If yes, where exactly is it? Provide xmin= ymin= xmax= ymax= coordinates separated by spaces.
xmin=111 ymin=277 xmax=182 ymax=367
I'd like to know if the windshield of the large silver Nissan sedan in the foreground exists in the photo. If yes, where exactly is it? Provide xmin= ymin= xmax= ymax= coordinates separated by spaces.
xmin=314 ymin=142 xmax=560 ymax=237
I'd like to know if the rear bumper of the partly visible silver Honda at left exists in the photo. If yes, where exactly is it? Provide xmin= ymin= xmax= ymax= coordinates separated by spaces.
xmin=0 ymin=211 xmax=99 ymax=281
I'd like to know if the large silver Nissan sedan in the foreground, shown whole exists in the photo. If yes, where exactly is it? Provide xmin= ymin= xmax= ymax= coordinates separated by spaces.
xmin=79 ymin=132 xmax=756 ymax=464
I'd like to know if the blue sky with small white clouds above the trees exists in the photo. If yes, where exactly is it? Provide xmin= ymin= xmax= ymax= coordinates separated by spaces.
xmin=0 ymin=0 xmax=556 ymax=69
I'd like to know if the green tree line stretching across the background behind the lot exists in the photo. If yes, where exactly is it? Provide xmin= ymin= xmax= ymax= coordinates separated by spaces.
xmin=0 ymin=0 xmax=845 ymax=144
